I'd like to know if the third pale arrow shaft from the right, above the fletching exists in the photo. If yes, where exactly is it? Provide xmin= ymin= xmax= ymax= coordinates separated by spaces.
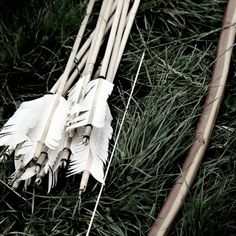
xmin=100 ymin=0 xmax=124 ymax=77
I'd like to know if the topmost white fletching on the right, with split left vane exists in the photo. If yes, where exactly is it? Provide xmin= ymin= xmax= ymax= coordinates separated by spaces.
xmin=67 ymin=79 xmax=113 ymax=131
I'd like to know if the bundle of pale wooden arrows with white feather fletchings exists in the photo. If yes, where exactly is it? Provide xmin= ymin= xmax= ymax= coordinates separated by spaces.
xmin=0 ymin=0 xmax=140 ymax=194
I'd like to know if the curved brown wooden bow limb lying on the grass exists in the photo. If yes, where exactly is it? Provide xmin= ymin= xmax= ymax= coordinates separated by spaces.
xmin=148 ymin=0 xmax=236 ymax=236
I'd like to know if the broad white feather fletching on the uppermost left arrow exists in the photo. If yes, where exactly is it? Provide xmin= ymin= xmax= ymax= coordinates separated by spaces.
xmin=0 ymin=94 xmax=69 ymax=148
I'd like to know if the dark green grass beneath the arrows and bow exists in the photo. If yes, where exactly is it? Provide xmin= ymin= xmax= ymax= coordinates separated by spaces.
xmin=0 ymin=0 xmax=236 ymax=236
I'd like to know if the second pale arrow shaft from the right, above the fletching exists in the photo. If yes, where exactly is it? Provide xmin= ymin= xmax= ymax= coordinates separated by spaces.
xmin=106 ymin=0 xmax=130 ymax=81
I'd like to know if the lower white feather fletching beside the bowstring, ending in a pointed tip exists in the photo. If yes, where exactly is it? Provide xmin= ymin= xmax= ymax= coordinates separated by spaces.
xmin=68 ymin=106 xmax=112 ymax=183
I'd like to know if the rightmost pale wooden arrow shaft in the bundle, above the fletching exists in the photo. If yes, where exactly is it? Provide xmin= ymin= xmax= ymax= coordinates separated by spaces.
xmin=111 ymin=0 xmax=140 ymax=81
